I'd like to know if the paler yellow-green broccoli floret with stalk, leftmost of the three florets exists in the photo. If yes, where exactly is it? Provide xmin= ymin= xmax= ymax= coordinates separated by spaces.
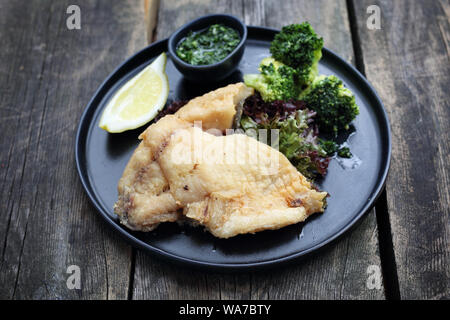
xmin=244 ymin=58 xmax=299 ymax=101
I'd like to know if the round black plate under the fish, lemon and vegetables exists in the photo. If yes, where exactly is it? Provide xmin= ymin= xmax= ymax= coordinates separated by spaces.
xmin=75 ymin=27 xmax=391 ymax=269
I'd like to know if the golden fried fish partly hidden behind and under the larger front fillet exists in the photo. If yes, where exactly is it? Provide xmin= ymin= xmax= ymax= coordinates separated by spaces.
xmin=114 ymin=83 xmax=253 ymax=231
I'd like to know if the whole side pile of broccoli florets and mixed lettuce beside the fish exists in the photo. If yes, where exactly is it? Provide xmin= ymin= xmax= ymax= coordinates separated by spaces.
xmin=239 ymin=22 xmax=359 ymax=179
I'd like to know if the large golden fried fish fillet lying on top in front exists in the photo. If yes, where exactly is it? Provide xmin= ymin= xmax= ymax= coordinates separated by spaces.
xmin=143 ymin=116 xmax=327 ymax=238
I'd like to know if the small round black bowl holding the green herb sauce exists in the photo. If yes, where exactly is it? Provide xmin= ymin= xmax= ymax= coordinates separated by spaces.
xmin=168 ymin=14 xmax=247 ymax=82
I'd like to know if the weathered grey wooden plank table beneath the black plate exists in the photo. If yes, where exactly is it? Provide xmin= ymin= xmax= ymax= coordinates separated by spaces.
xmin=0 ymin=0 xmax=450 ymax=299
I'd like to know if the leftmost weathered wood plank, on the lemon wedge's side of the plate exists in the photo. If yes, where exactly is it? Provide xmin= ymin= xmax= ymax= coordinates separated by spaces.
xmin=0 ymin=0 xmax=146 ymax=299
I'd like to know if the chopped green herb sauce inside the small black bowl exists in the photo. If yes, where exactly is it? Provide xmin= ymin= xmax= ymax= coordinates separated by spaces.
xmin=176 ymin=24 xmax=241 ymax=65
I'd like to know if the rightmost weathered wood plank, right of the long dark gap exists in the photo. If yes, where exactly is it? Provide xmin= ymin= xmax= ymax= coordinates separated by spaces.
xmin=354 ymin=0 xmax=450 ymax=299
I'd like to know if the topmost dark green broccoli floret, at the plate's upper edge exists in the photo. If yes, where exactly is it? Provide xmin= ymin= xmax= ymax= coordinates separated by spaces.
xmin=270 ymin=22 xmax=323 ymax=88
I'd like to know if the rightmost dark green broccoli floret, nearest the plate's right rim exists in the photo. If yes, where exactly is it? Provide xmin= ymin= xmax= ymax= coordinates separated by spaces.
xmin=299 ymin=76 xmax=359 ymax=134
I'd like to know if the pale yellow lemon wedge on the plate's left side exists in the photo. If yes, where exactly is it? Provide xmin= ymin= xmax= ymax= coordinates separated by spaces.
xmin=99 ymin=53 xmax=169 ymax=133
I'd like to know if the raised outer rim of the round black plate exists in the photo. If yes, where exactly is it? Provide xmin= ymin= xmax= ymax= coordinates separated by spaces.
xmin=75 ymin=25 xmax=392 ymax=271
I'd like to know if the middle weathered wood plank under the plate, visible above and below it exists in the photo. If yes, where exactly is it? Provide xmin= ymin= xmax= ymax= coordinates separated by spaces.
xmin=133 ymin=0 xmax=384 ymax=299
